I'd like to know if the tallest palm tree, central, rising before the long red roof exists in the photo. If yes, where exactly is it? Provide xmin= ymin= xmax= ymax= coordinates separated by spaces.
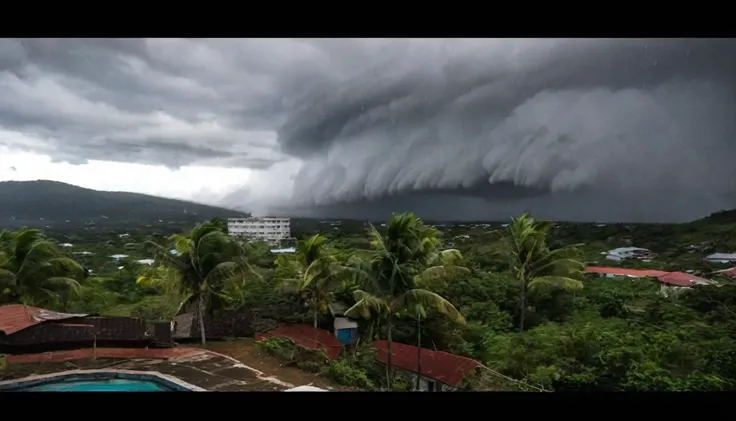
xmin=345 ymin=214 xmax=467 ymax=387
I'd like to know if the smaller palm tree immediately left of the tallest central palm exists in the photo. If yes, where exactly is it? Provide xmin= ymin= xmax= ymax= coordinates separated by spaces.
xmin=276 ymin=234 xmax=344 ymax=328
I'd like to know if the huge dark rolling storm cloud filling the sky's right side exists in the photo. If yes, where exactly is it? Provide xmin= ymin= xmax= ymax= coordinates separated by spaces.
xmin=280 ymin=40 xmax=736 ymax=220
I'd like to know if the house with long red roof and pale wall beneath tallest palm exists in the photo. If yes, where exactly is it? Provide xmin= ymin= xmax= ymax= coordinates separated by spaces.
xmin=373 ymin=340 xmax=481 ymax=392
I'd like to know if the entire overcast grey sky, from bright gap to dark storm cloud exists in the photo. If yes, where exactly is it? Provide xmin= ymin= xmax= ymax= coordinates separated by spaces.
xmin=0 ymin=39 xmax=736 ymax=221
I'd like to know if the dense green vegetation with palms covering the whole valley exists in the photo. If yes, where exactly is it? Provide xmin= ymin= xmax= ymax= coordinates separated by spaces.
xmin=0 ymin=212 xmax=736 ymax=391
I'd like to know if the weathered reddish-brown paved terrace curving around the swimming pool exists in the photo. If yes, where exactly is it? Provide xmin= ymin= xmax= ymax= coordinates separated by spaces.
xmin=0 ymin=347 xmax=297 ymax=392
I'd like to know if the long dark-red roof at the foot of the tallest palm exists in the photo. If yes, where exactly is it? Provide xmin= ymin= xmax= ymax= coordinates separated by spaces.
xmin=373 ymin=340 xmax=481 ymax=387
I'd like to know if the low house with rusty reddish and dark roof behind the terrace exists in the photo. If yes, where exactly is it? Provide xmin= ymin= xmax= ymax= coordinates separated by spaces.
xmin=0 ymin=304 xmax=172 ymax=354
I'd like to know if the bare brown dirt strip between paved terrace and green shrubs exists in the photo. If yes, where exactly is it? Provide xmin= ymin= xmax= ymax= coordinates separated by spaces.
xmin=204 ymin=339 xmax=344 ymax=389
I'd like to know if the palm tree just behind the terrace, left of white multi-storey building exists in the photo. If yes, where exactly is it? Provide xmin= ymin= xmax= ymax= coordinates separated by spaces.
xmin=138 ymin=220 xmax=258 ymax=345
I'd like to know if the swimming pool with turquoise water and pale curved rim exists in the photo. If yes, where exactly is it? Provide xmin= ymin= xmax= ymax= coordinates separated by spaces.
xmin=0 ymin=370 xmax=203 ymax=392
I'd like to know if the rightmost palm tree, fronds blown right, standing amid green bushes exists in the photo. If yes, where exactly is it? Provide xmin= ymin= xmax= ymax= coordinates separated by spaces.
xmin=500 ymin=213 xmax=585 ymax=332
